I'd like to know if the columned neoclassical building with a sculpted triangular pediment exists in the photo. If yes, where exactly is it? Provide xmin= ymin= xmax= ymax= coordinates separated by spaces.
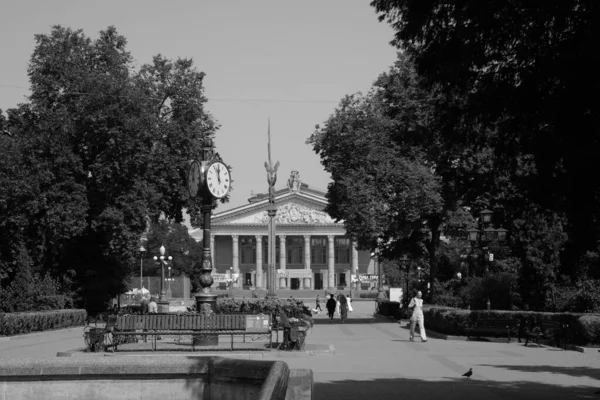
xmin=191 ymin=171 xmax=374 ymax=289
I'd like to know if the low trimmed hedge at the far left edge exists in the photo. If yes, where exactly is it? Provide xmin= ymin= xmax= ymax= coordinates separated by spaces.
xmin=0 ymin=310 xmax=87 ymax=336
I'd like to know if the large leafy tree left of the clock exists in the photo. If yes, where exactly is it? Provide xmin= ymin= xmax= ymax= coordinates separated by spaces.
xmin=3 ymin=26 xmax=217 ymax=308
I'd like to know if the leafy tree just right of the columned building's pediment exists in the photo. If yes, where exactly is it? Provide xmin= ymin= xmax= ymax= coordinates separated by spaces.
xmin=309 ymin=53 xmax=506 ymax=302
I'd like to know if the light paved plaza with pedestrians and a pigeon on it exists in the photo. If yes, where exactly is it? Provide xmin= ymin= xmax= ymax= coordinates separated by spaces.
xmin=0 ymin=301 xmax=600 ymax=400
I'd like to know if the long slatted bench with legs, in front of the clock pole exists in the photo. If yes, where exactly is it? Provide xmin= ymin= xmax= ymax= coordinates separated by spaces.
xmin=112 ymin=314 xmax=272 ymax=351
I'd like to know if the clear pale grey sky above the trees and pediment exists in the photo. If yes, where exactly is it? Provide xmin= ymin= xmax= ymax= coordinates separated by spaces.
xmin=0 ymin=0 xmax=396 ymax=212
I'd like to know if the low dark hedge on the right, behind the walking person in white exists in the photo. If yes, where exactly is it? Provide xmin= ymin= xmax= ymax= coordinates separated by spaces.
xmin=378 ymin=300 xmax=600 ymax=346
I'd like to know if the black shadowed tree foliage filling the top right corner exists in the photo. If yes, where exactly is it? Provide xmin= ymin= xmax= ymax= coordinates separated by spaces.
xmin=371 ymin=0 xmax=600 ymax=272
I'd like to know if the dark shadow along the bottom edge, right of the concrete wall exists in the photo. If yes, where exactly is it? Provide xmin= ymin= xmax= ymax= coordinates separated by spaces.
xmin=313 ymin=376 xmax=600 ymax=400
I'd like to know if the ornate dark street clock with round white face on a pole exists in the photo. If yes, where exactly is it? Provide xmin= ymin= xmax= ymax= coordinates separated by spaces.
xmin=187 ymin=138 xmax=231 ymax=346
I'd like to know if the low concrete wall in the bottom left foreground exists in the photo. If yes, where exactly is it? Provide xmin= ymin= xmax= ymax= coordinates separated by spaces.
xmin=0 ymin=356 xmax=312 ymax=400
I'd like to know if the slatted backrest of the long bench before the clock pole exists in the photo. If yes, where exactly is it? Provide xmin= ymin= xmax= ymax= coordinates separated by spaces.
xmin=115 ymin=314 xmax=271 ymax=332
